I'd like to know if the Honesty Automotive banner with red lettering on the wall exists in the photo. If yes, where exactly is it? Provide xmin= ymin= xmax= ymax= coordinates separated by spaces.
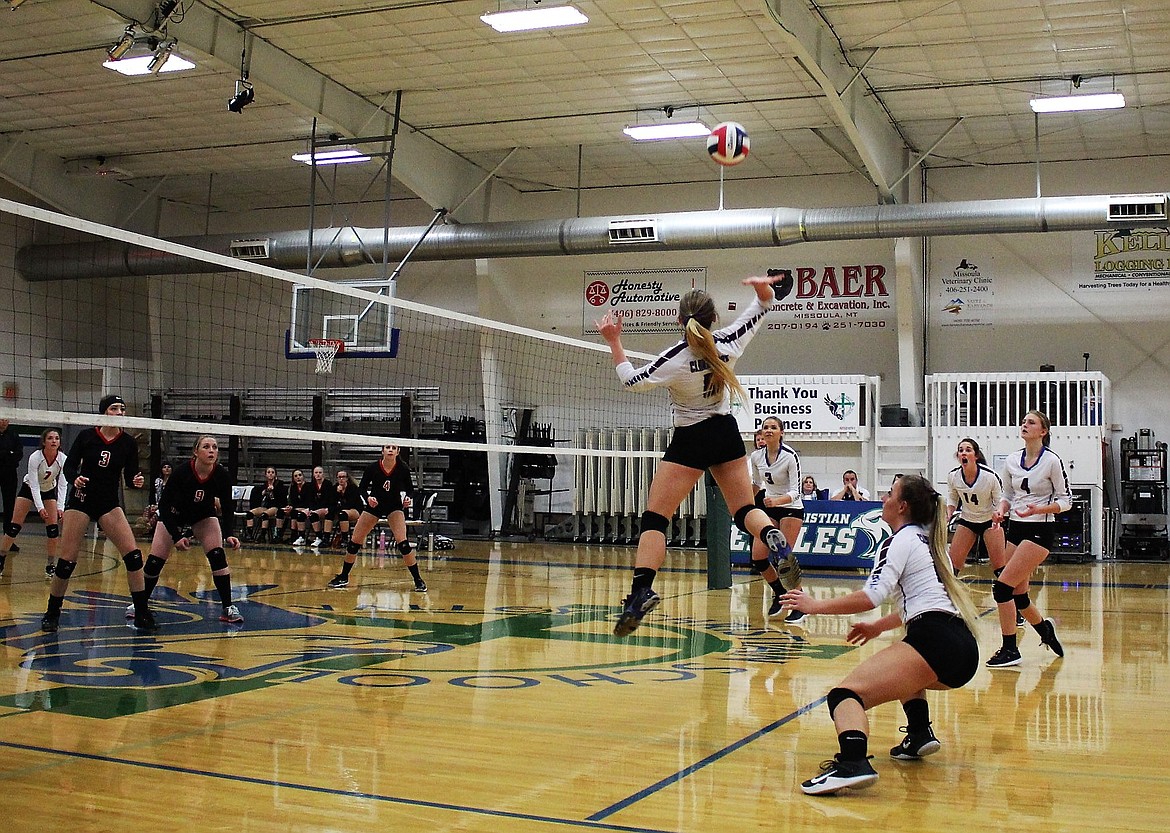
xmin=581 ymin=267 xmax=707 ymax=336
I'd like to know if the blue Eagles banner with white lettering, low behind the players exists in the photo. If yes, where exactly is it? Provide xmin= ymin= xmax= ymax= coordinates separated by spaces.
xmin=730 ymin=501 xmax=893 ymax=570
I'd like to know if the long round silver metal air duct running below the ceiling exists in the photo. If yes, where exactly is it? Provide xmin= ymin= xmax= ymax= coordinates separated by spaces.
xmin=16 ymin=193 xmax=1170 ymax=281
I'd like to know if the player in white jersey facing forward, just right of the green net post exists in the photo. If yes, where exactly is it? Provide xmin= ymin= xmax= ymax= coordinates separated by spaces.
xmin=750 ymin=417 xmax=805 ymax=625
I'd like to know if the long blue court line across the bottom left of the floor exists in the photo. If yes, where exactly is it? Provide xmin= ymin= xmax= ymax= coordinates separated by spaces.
xmin=0 ymin=741 xmax=675 ymax=833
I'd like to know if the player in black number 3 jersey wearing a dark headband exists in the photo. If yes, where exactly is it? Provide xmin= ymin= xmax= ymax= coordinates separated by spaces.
xmin=41 ymin=394 xmax=156 ymax=633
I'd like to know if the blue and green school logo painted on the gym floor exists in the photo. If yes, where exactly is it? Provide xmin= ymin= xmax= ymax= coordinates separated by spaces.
xmin=0 ymin=585 xmax=848 ymax=718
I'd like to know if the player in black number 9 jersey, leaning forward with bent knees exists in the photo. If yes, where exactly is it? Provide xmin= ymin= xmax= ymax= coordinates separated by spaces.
xmin=126 ymin=434 xmax=243 ymax=625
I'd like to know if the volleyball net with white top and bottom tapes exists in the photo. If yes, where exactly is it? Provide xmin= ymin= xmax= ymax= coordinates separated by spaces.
xmin=0 ymin=200 xmax=683 ymax=526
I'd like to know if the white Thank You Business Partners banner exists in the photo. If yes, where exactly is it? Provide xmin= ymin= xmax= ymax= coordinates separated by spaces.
xmin=731 ymin=381 xmax=862 ymax=434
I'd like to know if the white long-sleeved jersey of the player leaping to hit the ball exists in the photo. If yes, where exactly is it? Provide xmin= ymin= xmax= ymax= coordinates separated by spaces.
xmin=615 ymin=296 xmax=768 ymax=427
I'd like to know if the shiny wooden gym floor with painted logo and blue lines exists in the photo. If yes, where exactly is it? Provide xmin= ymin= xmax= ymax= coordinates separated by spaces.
xmin=0 ymin=535 xmax=1170 ymax=833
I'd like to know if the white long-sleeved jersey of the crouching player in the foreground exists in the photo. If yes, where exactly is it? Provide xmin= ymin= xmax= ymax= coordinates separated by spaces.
xmin=862 ymin=524 xmax=958 ymax=622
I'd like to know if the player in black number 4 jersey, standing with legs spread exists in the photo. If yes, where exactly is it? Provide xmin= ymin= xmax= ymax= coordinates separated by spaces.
xmin=326 ymin=445 xmax=427 ymax=593
